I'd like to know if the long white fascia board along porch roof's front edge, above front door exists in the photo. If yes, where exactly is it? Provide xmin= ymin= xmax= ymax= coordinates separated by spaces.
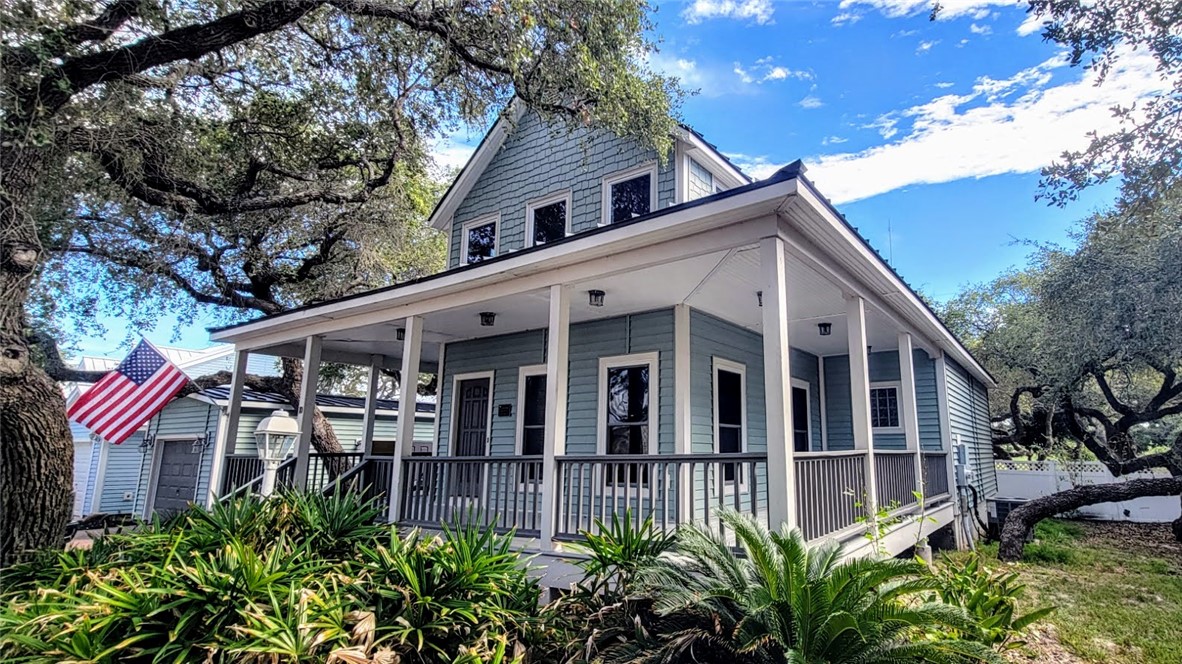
xmin=217 ymin=180 xmax=797 ymax=349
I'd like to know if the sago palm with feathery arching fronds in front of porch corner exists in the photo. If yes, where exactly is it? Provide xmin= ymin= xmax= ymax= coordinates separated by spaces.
xmin=606 ymin=512 xmax=1000 ymax=664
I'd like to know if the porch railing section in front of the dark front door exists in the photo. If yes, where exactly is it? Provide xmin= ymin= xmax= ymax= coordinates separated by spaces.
xmin=398 ymin=456 xmax=541 ymax=535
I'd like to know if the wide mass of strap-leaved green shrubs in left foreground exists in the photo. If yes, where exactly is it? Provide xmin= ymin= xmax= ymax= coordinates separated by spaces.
xmin=0 ymin=493 xmax=539 ymax=664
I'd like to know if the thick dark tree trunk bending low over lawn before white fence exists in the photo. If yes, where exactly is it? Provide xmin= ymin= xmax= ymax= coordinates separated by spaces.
xmin=998 ymin=477 xmax=1182 ymax=562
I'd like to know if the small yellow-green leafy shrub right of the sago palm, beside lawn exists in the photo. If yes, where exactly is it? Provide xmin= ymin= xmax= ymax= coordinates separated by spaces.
xmin=931 ymin=554 xmax=1054 ymax=650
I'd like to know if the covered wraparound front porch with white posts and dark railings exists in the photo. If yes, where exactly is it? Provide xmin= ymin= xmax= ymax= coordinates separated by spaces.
xmin=215 ymin=178 xmax=952 ymax=551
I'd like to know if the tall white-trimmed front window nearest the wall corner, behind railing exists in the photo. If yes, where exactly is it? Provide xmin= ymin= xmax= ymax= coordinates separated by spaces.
xmin=599 ymin=353 xmax=657 ymax=482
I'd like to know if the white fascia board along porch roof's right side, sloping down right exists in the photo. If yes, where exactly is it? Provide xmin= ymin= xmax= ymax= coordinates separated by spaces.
xmin=784 ymin=184 xmax=998 ymax=388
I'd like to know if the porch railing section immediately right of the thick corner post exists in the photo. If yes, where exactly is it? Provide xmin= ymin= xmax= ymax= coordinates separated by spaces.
xmin=794 ymin=450 xmax=869 ymax=540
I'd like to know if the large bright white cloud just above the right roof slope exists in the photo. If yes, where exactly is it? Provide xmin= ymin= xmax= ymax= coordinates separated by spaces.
xmin=803 ymin=54 xmax=1162 ymax=202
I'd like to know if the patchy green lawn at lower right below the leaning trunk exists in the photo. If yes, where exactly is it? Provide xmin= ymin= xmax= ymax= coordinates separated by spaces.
xmin=959 ymin=521 xmax=1182 ymax=664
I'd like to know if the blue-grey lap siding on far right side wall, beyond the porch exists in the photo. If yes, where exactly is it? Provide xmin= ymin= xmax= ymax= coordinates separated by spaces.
xmin=946 ymin=359 xmax=998 ymax=497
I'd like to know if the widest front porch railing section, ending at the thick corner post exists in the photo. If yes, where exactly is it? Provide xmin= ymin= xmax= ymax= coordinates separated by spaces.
xmin=556 ymin=454 xmax=767 ymax=538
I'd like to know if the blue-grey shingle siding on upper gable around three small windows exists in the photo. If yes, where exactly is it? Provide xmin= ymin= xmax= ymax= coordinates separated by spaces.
xmin=448 ymin=113 xmax=675 ymax=267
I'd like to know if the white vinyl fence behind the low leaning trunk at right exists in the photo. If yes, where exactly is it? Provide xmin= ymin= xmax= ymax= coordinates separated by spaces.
xmin=996 ymin=461 xmax=1182 ymax=522
